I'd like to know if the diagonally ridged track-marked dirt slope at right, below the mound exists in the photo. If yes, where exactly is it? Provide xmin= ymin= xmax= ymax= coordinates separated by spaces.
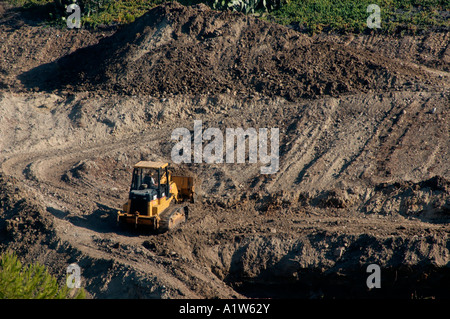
xmin=268 ymin=89 xmax=448 ymax=200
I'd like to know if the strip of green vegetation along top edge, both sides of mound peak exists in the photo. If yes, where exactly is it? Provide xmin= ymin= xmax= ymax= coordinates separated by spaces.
xmin=9 ymin=0 xmax=450 ymax=33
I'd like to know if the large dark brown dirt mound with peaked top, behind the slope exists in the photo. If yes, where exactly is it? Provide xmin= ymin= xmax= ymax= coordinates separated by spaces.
xmin=51 ymin=2 xmax=444 ymax=100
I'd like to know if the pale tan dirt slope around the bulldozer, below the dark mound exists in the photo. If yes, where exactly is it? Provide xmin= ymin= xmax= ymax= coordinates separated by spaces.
xmin=1 ymin=88 xmax=450 ymax=298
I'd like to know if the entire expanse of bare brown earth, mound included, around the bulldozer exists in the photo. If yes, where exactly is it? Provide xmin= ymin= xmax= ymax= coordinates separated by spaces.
xmin=0 ymin=2 xmax=450 ymax=298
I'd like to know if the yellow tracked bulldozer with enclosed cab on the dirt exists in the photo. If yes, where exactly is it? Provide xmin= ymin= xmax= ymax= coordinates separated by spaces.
xmin=117 ymin=161 xmax=195 ymax=232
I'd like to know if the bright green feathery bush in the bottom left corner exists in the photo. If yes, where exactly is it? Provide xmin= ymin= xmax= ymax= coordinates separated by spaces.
xmin=0 ymin=253 xmax=85 ymax=299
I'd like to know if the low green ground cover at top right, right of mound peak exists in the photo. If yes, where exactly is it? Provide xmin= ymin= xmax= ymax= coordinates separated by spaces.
xmin=268 ymin=0 xmax=450 ymax=32
